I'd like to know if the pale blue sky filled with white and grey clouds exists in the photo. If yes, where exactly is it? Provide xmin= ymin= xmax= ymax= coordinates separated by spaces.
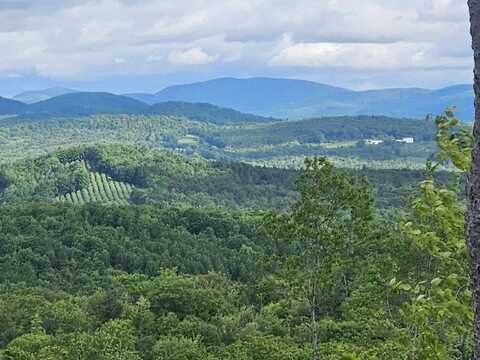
xmin=0 ymin=0 xmax=472 ymax=96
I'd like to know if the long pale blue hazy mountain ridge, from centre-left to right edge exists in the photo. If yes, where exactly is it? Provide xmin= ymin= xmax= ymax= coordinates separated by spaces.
xmin=128 ymin=78 xmax=474 ymax=121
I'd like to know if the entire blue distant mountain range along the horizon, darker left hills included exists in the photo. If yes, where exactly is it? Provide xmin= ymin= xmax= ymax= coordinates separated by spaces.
xmin=7 ymin=78 xmax=474 ymax=123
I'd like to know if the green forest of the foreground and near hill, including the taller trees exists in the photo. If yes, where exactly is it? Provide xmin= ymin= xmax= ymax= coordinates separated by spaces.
xmin=0 ymin=113 xmax=472 ymax=360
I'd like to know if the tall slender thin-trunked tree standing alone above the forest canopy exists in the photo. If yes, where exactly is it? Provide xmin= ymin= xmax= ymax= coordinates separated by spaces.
xmin=265 ymin=158 xmax=373 ymax=360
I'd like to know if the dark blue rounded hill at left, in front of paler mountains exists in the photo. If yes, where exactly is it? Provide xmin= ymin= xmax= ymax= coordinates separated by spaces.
xmin=26 ymin=92 xmax=148 ymax=116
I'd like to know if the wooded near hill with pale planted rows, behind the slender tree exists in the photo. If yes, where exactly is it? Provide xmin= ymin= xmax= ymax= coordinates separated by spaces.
xmin=0 ymin=145 xmax=458 ymax=210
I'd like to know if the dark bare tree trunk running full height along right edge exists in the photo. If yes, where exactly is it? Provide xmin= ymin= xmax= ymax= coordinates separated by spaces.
xmin=465 ymin=0 xmax=480 ymax=360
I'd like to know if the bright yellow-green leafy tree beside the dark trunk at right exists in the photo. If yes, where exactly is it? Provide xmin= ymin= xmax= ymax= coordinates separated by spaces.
xmin=390 ymin=110 xmax=473 ymax=360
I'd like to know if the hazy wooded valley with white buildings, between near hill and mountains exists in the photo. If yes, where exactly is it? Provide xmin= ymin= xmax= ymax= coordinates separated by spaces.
xmin=0 ymin=112 xmax=450 ymax=170
